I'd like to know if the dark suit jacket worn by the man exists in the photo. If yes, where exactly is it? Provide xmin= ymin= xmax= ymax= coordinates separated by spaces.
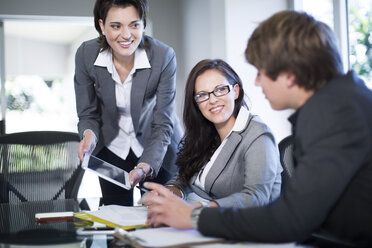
xmin=198 ymin=72 xmax=372 ymax=246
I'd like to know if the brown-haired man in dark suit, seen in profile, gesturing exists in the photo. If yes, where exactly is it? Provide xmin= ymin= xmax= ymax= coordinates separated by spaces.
xmin=144 ymin=11 xmax=372 ymax=246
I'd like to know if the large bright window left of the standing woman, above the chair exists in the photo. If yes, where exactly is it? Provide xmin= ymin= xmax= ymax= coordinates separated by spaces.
xmin=3 ymin=18 xmax=97 ymax=133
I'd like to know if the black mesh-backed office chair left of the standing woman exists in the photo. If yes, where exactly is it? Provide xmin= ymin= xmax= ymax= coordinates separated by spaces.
xmin=0 ymin=131 xmax=84 ymax=203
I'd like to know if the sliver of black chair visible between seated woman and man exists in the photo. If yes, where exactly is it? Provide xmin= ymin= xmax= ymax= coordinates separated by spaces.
xmin=278 ymin=135 xmax=295 ymax=190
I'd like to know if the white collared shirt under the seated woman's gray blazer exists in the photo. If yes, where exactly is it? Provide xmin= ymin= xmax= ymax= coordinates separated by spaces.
xmin=195 ymin=106 xmax=249 ymax=190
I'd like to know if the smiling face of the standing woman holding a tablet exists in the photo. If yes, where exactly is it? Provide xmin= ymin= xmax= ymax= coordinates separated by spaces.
xmin=99 ymin=6 xmax=144 ymax=59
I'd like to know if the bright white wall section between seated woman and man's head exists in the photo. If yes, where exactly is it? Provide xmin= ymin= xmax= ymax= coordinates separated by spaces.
xmin=225 ymin=0 xmax=292 ymax=142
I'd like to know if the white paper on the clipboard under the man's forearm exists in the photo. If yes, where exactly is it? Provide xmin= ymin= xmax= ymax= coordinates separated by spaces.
xmin=117 ymin=227 xmax=225 ymax=248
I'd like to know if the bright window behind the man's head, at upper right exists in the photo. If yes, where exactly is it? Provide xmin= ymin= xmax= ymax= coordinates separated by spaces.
xmin=291 ymin=0 xmax=372 ymax=89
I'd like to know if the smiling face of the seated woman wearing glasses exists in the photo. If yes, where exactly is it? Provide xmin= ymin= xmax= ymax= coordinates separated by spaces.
xmin=194 ymin=69 xmax=239 ymax=132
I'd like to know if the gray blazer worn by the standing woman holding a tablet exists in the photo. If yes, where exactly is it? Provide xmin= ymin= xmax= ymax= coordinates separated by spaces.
xmin=74 ymin=36 xmax=183 ymax=173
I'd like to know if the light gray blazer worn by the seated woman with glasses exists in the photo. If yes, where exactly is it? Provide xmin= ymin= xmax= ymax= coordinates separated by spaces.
xmin=167 ymin=115 xmax=282 ymax=208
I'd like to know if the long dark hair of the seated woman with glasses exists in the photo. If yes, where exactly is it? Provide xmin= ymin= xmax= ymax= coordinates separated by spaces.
xmin=176 ymin=59 xmax=246 ymax=183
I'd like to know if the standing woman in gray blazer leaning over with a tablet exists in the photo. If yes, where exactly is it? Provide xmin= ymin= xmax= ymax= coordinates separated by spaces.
xmin=74 ymin=0 xmax=182 ymax=205
